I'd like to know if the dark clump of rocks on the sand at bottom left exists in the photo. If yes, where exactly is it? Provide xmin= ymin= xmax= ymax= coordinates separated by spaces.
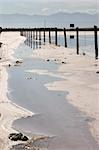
xmin=9 ymin=133 xmax=28 ymax=141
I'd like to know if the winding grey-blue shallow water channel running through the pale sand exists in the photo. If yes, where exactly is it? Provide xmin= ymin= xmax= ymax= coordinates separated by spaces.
xmin=8 ymin=41 xmax=99 ymax=150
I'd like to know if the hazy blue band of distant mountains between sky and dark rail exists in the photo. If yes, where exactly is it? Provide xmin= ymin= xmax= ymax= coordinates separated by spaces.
xmin=0 ymin=12 xmax=99 ymax=27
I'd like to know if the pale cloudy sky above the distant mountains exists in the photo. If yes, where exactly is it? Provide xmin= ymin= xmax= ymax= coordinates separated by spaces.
xmin=0 ymin=0 xmax=99 ymax=15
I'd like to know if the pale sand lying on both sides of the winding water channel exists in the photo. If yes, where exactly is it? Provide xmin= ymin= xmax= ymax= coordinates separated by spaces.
xmin=0 ymin=33 xmax=99 ymax=150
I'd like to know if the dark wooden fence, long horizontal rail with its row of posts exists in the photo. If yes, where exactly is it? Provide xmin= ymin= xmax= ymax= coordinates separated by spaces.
xmin=0 ymin=26 xmax=99 ymax=59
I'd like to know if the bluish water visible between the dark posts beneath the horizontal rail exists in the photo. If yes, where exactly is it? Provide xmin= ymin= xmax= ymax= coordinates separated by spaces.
xmin=23 ymin=32 xmax=99 ymax=57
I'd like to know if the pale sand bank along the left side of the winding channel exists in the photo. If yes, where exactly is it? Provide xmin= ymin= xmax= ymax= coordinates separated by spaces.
xmin=0 ymin=33 xmax=33 ymax=150
